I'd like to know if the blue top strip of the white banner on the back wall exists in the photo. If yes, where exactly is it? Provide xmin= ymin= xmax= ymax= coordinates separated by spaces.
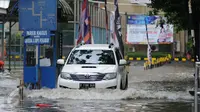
xmin=127 ymin=15 xmax=159 ymax=25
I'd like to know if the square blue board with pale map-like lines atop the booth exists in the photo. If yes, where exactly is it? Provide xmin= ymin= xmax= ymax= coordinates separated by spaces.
xmin=19 ymin=0 xmax=57 ymax=31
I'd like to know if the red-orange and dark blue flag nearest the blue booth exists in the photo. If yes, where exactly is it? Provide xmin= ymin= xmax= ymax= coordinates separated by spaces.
xmin=77 ymin=0 xmax=92 ymax=44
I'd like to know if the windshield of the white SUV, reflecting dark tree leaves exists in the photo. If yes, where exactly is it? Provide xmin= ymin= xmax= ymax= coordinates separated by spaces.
xmin=67 ymin=50 xmax=115 ymax=65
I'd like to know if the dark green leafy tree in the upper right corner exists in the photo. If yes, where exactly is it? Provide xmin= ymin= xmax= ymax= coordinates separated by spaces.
xmin=150 ymin=0 xmax=200 ymax=60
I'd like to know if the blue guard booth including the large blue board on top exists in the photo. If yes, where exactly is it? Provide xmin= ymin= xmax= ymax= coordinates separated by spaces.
xmin=19 ymin=0 xmax=57 ymax=89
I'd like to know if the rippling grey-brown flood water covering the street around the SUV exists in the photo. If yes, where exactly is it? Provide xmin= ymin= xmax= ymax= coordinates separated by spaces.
xmin=0 ymin=62 xmax=194 ymax=112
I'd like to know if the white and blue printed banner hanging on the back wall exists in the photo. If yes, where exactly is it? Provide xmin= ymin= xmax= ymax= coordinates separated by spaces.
xmin=126 ymin=15 xmax=173 ymax=44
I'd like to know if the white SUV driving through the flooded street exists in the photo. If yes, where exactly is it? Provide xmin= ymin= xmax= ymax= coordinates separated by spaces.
xmin=57 ymin=44 xmax=128 ymax=90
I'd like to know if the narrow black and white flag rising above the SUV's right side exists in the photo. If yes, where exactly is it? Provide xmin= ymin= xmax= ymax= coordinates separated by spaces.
xmin=114 ymin=0 xmax=124 ymax=57
